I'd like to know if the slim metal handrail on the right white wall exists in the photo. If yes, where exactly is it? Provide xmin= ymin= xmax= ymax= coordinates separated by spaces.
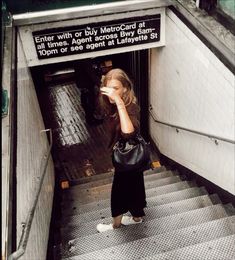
xmin=149 ymin=105 xmax=235 ymax=145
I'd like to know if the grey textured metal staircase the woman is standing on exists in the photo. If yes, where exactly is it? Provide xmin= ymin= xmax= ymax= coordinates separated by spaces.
xmin=55 ymin=167 xmax=235 ymax=260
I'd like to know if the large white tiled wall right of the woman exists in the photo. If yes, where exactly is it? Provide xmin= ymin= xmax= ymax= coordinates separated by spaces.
xmin=150 ymin=10 xmax=235 ymax=194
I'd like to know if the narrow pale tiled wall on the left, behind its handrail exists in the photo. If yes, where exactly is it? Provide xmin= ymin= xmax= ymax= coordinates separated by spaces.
xmin=17 ymin=35 xmax=54 ymax=260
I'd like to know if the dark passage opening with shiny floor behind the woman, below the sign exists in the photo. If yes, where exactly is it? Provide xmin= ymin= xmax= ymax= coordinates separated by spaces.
xmin=31 ymin=50 xmax=156 ymax=185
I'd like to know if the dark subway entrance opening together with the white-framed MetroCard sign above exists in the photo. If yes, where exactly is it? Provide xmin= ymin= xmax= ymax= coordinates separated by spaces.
xmin=24 ymin=5 xmax=165 ymax=184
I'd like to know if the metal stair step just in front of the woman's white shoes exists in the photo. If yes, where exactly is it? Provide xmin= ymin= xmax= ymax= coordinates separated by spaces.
xmin=58 ymin=204 xmax=227 ymax=258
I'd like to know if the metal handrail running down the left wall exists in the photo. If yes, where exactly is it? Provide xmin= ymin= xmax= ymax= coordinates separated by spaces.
xmin=8 ymin=129 xmax=52 ymax=260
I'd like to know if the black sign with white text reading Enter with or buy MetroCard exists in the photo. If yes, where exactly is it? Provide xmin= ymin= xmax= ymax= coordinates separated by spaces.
xmin=32 ymin=14 xmax=161 ymax=60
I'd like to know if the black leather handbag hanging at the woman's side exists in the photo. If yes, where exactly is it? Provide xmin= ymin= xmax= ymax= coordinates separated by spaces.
xmin=112 ymin=134 xmax=151 ymax=172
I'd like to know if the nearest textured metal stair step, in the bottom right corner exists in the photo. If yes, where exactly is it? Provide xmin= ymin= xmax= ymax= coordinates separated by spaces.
xmin=142 ymin=235 xmax=235 ymax=260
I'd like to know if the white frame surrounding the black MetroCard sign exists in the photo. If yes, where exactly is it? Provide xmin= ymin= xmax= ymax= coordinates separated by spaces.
xmin=19 ymin=8 xmax=165 ymax=67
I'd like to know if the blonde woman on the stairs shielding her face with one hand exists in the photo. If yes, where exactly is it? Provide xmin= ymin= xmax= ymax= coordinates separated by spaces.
xmin=97 ymin=69 xmax=146 ymax=232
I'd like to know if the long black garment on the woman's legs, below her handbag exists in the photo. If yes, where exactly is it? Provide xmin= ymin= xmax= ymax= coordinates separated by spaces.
xmin=111 ymin=172 xmax=147 ymax=217
